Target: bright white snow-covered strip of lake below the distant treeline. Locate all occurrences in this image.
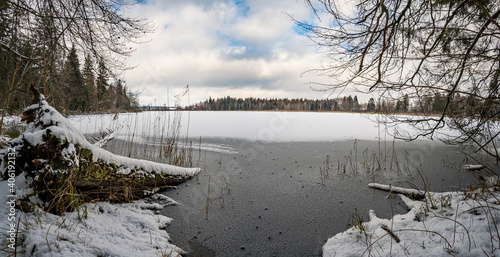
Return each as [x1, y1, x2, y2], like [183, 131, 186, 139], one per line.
[71, 111, 414, 142]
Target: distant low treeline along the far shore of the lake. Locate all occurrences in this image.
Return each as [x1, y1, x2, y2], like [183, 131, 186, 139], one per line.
[188, 93, 500, 116]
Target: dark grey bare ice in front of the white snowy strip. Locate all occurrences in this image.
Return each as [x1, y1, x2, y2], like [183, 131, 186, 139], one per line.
[103, 138, 482, 256]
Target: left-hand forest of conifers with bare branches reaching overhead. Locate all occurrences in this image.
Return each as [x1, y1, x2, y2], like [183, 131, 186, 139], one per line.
[0, 1, 145, 117]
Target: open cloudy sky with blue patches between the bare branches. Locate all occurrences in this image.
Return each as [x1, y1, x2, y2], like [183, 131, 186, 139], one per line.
[121, 0, 336, 105]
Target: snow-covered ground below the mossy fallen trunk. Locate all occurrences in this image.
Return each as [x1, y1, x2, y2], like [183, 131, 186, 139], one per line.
[0, 177, 186, 257]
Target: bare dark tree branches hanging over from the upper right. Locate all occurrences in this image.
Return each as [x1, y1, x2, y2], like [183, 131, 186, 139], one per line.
[296, 0, 500, 159]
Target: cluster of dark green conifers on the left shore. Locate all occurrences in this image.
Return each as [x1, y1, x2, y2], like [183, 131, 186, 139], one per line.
[0, 44, 139, 113]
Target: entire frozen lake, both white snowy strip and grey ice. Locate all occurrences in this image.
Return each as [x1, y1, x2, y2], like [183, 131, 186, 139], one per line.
[71, 112, 488, 256]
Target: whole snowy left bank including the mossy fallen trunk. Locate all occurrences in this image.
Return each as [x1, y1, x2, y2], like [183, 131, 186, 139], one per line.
[0, 92, 200, 254]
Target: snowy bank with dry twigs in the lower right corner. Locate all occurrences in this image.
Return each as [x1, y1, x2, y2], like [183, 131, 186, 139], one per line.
[323, 184, 500, 257]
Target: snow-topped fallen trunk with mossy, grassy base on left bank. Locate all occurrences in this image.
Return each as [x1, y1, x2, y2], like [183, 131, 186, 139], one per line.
[0, 89, 200, 213]
